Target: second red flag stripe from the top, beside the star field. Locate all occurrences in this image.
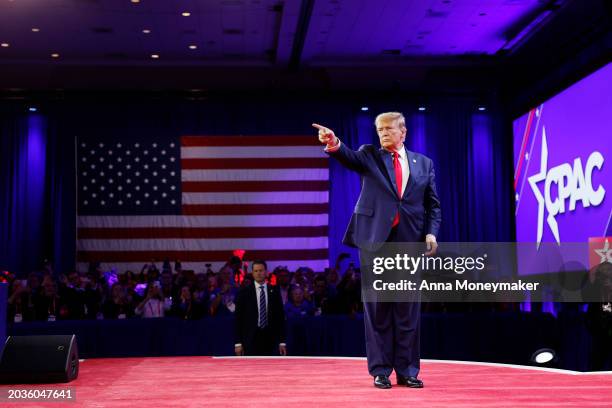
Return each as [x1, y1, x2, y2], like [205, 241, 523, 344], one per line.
[181, 157, 328, 170]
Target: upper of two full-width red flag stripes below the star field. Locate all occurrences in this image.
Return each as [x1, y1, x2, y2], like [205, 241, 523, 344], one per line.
[78, 226, 328, 239]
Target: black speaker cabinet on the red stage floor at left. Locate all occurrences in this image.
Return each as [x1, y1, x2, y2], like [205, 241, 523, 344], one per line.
[0, 334, 79, 384]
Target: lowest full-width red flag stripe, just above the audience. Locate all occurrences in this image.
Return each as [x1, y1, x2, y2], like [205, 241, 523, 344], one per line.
[77, 249, 328, 262]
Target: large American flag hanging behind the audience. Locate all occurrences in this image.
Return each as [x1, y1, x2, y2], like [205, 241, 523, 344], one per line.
[76, 136, 329, 272]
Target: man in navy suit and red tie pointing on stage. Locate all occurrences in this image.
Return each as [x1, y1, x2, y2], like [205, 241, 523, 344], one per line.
[313, 112, 441, 388]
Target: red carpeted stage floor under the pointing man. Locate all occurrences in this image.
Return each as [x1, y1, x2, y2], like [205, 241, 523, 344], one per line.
[4, 357, 612, 408]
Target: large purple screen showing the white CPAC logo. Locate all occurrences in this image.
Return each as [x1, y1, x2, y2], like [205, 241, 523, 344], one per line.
[513, 64, 612, 274]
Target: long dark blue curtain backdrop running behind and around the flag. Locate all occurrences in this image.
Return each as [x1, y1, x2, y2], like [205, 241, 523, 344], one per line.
[0, 98, 514, 275]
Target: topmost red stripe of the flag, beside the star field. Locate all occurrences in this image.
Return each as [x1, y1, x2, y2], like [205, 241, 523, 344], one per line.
[181, 135, 321, 147]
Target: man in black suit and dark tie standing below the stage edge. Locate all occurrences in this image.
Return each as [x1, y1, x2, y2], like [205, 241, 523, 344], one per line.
[234, 260, 287, 356]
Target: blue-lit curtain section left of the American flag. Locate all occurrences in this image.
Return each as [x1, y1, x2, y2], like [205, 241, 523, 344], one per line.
[0, 110, 75, 276]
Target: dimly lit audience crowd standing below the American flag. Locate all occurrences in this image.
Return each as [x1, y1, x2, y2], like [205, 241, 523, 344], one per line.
[6, 257, 363, 323]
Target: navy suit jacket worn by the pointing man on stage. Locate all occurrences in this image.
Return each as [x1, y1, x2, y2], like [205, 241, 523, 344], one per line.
[328, 143, 442, 250]
